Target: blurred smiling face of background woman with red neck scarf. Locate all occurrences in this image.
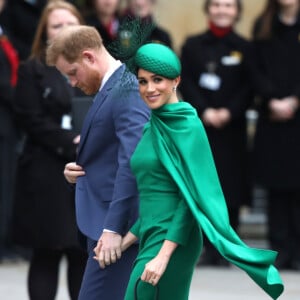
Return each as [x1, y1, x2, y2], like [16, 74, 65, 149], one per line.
[208, 0, 239, 28]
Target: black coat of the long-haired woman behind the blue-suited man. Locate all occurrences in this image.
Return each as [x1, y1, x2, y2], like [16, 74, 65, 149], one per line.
[13, 60, 81, 248]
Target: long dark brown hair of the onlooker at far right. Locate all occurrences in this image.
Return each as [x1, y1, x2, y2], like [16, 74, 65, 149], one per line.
[254, 0, 300, 40]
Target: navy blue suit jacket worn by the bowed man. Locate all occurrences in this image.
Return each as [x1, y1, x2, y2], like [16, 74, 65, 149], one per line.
[76, 65, 150, 241]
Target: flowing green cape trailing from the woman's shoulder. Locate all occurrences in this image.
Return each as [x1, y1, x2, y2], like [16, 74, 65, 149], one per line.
[150, 102, 284, 299]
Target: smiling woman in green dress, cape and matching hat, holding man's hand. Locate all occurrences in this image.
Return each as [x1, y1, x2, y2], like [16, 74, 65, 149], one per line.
[96, 43, 283, 300]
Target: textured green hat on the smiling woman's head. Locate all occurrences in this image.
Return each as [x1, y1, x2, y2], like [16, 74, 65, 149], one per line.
[135, 43, 181, 79]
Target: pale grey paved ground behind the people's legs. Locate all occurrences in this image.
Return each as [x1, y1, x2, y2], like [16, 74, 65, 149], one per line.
[0, 262, 300, 300]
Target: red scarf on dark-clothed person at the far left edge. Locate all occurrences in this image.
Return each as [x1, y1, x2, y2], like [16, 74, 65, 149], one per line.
[0, 36, 19, 87]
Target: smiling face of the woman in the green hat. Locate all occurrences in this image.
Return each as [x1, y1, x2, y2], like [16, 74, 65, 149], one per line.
[138, 69, 180, 109]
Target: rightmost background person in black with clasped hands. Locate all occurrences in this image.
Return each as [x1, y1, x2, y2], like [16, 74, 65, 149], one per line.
[253, 0, 300, 270]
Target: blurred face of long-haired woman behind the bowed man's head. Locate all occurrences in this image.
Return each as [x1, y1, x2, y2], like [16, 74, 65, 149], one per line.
[47, 8, 79, 41]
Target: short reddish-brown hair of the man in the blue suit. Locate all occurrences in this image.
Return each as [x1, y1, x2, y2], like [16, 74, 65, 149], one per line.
[46, 25, 103, 66]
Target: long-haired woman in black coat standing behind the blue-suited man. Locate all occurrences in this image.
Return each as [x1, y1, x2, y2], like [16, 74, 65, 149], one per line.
[13, 0, 87, 300]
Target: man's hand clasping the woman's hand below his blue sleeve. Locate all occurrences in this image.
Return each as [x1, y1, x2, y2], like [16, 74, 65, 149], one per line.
[94, 232, 122, 269]
